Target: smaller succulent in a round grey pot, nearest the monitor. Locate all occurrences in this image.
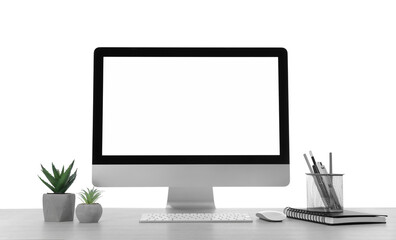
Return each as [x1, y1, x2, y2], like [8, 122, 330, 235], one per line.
[76, 187, 103, 223]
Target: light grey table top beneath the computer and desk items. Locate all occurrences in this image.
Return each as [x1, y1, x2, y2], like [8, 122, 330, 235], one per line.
[0, 208, 396, 240]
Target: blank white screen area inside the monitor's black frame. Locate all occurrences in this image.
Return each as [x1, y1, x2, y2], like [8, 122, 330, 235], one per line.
[102, 57, 279, 155]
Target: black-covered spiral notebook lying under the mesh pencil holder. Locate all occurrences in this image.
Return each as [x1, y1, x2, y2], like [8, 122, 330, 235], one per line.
[283, 207, 387, 225]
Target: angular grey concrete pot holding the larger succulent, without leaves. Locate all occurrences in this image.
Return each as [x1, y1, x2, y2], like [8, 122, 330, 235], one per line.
[43, 193, 76, 222]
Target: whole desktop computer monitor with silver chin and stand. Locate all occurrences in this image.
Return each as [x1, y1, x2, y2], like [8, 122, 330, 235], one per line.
[92, 48, 290, 208]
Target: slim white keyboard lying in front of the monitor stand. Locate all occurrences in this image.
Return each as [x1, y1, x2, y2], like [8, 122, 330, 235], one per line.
[140, 213, 253, 223]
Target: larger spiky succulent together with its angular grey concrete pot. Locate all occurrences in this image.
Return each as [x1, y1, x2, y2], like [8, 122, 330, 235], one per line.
[39, 160, 77, 222]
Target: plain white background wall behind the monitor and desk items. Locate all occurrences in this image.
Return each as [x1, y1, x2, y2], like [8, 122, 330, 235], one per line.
[0, 0, 396, 208]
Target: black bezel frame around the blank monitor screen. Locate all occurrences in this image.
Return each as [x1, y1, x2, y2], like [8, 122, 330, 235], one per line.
[92, 47, 289, 165]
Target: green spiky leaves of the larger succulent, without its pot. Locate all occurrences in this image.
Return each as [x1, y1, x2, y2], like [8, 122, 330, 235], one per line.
[39, 160, 77, 193]
